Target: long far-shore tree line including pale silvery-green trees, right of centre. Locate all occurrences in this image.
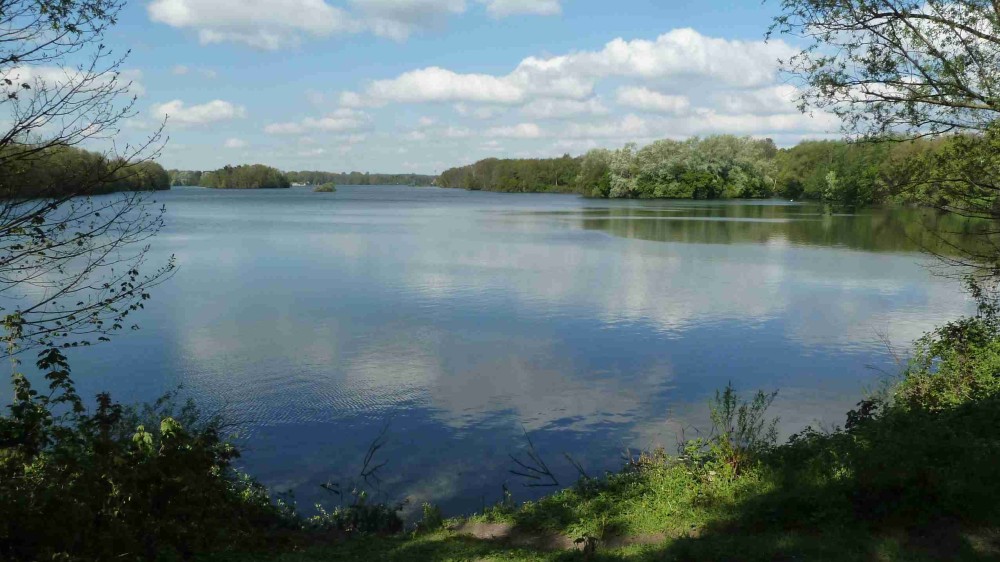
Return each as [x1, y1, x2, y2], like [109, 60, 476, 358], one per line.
[437, 135, 956, 206]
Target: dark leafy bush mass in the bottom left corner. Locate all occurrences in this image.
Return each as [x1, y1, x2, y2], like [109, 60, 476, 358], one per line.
[0, 349, 295, 560]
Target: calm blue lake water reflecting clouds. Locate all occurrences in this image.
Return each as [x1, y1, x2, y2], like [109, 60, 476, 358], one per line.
[62, 187, 971, 514]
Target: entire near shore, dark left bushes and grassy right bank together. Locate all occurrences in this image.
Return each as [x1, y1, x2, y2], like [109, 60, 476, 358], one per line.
[0, 294, 1000, 562]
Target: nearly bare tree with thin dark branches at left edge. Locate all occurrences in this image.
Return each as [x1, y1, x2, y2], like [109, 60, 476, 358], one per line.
[0, 0, 173, 356]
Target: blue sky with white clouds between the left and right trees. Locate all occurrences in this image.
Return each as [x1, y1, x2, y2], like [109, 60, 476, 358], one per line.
[99, 0, 838, 174]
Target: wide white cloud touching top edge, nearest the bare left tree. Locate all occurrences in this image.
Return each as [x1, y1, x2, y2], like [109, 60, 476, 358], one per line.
[147, 0, 362, 49]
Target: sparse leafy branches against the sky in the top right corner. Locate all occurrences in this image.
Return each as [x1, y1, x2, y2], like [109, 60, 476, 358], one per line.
[771, 0, 1000, 138]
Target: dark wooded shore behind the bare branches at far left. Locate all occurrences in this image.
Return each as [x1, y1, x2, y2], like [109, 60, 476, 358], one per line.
[0, 145, 170, 199]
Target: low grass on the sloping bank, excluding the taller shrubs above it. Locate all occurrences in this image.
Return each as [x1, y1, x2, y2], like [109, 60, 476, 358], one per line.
[208, 392, 1000, 562]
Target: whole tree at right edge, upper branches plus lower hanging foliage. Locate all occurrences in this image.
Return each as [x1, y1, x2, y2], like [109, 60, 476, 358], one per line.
[771, 0, 1000, 274]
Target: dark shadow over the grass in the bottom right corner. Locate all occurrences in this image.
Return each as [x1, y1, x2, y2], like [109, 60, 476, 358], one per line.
[632, 399, 1000, 561]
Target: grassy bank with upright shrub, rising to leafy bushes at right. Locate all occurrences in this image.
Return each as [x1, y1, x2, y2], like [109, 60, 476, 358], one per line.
[207, 296, 1000, 562]
